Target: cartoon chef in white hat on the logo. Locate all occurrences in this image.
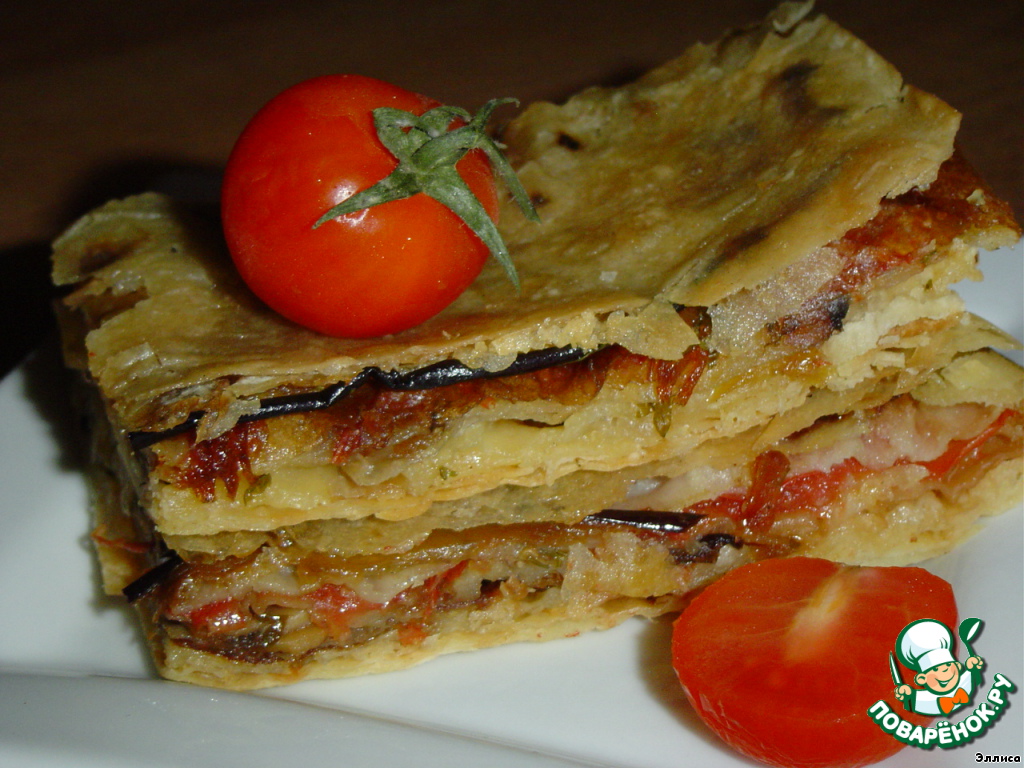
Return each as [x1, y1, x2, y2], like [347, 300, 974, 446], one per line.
[894, 618, 985, 716]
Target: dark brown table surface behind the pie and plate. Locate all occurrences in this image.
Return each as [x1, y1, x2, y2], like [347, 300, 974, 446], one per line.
[0, 0, 1024, 373]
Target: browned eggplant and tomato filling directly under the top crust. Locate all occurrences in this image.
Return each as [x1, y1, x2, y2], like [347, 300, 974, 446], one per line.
[138, 155, 999, 502]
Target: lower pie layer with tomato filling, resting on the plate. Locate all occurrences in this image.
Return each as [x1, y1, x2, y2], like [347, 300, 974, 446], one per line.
[90, 352, 1024, 688]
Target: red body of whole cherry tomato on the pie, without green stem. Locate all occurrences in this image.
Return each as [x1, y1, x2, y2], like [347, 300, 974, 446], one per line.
[221, 75, 498, 338]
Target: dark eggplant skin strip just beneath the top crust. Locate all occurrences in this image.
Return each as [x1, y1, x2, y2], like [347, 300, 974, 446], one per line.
[128, 346, 594, 451]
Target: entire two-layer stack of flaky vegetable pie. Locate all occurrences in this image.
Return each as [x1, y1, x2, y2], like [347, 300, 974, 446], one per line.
[53, 5, 1021, 687]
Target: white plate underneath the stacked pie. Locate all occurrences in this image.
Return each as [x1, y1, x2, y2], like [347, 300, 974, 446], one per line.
[0, 245, 1024, 768]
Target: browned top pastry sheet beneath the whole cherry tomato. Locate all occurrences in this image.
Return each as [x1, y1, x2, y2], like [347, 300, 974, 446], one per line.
[54, 6, 1016, 434]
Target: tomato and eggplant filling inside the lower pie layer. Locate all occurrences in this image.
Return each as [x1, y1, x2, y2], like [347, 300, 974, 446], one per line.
[129, 396, 1024, 665]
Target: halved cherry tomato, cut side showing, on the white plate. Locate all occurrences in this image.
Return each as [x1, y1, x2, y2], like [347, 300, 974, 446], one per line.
[672, 557, 956, 768]
